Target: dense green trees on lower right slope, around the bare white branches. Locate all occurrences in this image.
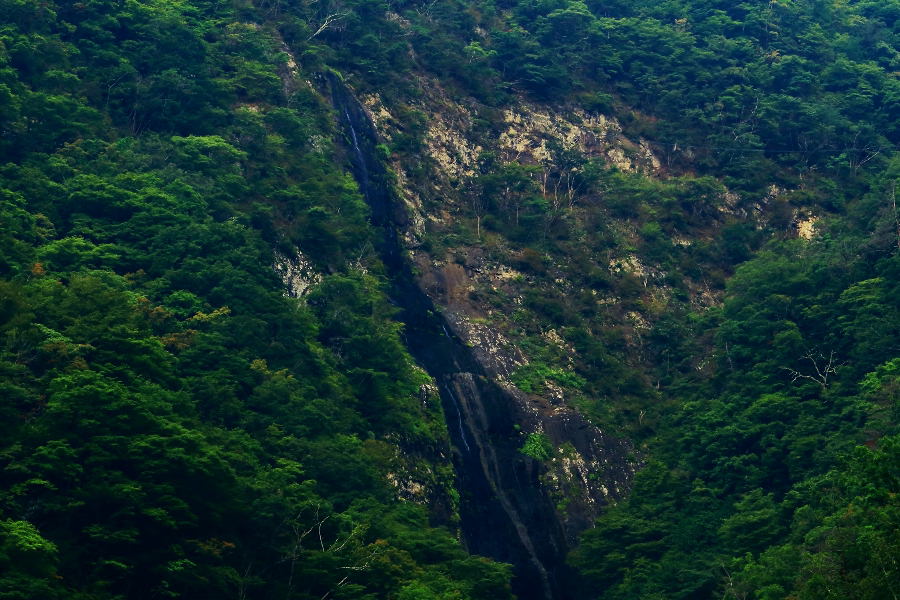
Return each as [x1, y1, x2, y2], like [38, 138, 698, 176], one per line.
[571, 220, 898, 599]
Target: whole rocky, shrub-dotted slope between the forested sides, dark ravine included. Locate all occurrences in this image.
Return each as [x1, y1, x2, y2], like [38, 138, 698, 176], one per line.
[310, 52, 892, 598]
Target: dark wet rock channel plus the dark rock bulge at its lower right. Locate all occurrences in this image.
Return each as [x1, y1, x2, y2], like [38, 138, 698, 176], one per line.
[328, 77, 636, 598]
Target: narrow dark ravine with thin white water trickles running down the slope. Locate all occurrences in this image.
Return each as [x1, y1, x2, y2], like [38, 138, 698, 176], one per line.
[327, 76, 632, 600]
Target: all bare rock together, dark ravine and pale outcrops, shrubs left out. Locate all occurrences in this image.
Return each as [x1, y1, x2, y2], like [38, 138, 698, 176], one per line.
[308, 70, 744, 598]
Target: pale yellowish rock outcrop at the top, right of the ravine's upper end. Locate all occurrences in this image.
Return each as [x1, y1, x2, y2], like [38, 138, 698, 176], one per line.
[362, 79, 661, 248]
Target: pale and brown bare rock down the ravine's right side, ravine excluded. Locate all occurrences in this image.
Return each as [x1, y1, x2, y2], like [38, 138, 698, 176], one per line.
[365, 77, 648, 576]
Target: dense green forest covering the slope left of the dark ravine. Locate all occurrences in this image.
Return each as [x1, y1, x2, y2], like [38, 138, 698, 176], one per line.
[0, 1, 510, 600]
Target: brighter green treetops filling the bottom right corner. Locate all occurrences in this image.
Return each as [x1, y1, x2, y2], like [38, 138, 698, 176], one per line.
[735, 436, 900, 600]
